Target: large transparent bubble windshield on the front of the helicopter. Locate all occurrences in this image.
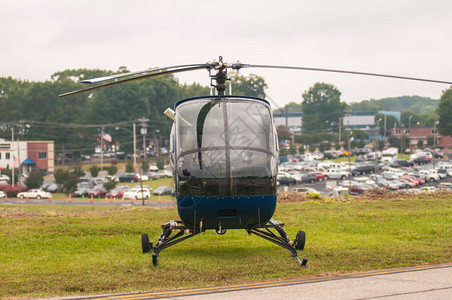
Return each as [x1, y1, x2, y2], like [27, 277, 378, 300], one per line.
[175, 97, 277, 196]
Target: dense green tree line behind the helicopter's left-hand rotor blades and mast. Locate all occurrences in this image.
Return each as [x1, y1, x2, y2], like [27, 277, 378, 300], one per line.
[0, 67, 266, 155]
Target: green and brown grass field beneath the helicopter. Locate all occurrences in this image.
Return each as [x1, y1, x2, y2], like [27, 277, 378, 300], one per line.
[0, 194, 452, 298]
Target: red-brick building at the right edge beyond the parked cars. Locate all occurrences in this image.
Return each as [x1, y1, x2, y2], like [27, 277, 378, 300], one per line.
[391, 127, 452, 150]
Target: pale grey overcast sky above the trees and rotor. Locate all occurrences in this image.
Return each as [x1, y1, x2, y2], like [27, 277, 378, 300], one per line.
[0, 0, 452, 106]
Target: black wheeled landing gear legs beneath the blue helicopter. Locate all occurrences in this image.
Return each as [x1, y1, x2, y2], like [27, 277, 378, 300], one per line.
[141, 219, 308, 266]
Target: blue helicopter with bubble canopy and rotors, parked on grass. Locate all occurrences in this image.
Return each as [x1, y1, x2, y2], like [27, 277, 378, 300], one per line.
[60, 56, 451, 266]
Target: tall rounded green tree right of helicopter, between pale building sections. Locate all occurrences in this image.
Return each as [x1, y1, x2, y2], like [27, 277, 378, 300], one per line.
[302, 83, 347, 133]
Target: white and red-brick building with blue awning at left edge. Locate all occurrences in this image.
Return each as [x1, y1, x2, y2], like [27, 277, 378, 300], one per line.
[0, 139, 55, 174]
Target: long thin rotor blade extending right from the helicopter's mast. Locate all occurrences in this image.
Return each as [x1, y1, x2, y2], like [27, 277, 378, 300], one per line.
[240, 64, 452, 84]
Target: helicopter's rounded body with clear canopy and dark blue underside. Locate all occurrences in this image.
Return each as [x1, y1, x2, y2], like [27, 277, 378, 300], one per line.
[170, 96, 278, 230]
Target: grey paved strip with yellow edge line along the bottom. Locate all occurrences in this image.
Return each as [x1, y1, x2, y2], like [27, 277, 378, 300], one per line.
[85, 263, 452, 300]
